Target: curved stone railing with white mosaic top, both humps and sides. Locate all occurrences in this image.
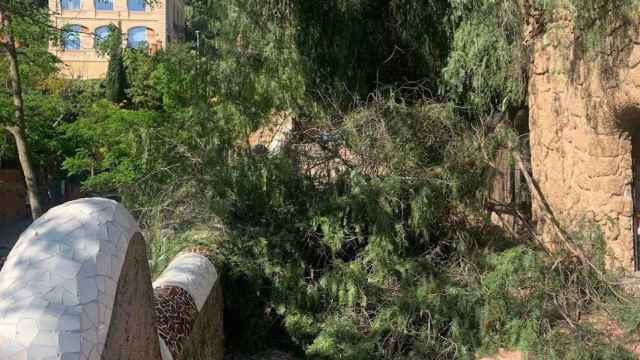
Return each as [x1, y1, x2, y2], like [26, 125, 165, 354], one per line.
[0, 199, 223, 360]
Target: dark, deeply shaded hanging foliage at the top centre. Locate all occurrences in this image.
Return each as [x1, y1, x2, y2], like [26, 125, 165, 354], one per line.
[292, 0, 450, 101]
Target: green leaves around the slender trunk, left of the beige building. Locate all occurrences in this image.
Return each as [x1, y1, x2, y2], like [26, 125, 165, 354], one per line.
[0, 0, 66, 172]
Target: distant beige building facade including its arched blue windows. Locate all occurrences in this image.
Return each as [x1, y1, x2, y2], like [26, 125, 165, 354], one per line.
[49, 0, 185, 79]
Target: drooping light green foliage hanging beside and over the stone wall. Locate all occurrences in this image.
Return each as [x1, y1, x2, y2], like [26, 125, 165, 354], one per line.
[440, 0, 638, 113]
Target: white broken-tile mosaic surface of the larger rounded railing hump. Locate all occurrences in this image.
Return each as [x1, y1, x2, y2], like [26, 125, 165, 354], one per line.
[0, 198, 139, 360]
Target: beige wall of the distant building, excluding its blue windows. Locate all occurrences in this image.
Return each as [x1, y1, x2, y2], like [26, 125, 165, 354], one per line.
[49, 0, 185, 79]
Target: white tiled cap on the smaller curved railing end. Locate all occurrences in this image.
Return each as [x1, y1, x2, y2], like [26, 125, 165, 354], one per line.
[153, 253, 218, 311]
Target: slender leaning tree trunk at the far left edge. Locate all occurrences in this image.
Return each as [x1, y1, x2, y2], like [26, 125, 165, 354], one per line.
[0, 8, 42, 220]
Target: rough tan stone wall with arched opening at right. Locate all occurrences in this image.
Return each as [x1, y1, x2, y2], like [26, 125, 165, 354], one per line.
[528, 11, 640, 271]
